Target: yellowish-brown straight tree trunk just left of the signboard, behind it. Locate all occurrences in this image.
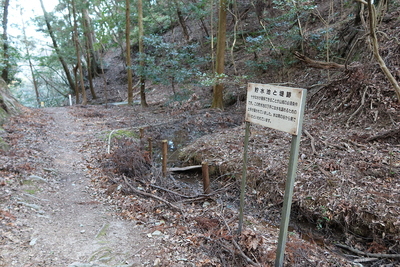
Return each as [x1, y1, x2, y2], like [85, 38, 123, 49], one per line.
[211, 0, 228, 109]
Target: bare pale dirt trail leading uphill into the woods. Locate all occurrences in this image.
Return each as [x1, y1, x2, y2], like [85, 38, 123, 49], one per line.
[0, 108, 160, 267]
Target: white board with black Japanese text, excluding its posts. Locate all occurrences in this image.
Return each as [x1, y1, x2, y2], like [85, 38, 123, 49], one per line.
[246, 83, 305, 135]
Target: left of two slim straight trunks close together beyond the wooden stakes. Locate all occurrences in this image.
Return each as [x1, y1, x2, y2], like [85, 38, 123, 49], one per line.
[125, 0, 133, 105]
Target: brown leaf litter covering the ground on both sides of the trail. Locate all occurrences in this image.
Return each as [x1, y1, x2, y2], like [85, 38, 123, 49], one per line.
[0, 91, 400, 266]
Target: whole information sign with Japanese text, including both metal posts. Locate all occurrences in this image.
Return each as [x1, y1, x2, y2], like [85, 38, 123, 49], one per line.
[238, 83, 307, 267]
